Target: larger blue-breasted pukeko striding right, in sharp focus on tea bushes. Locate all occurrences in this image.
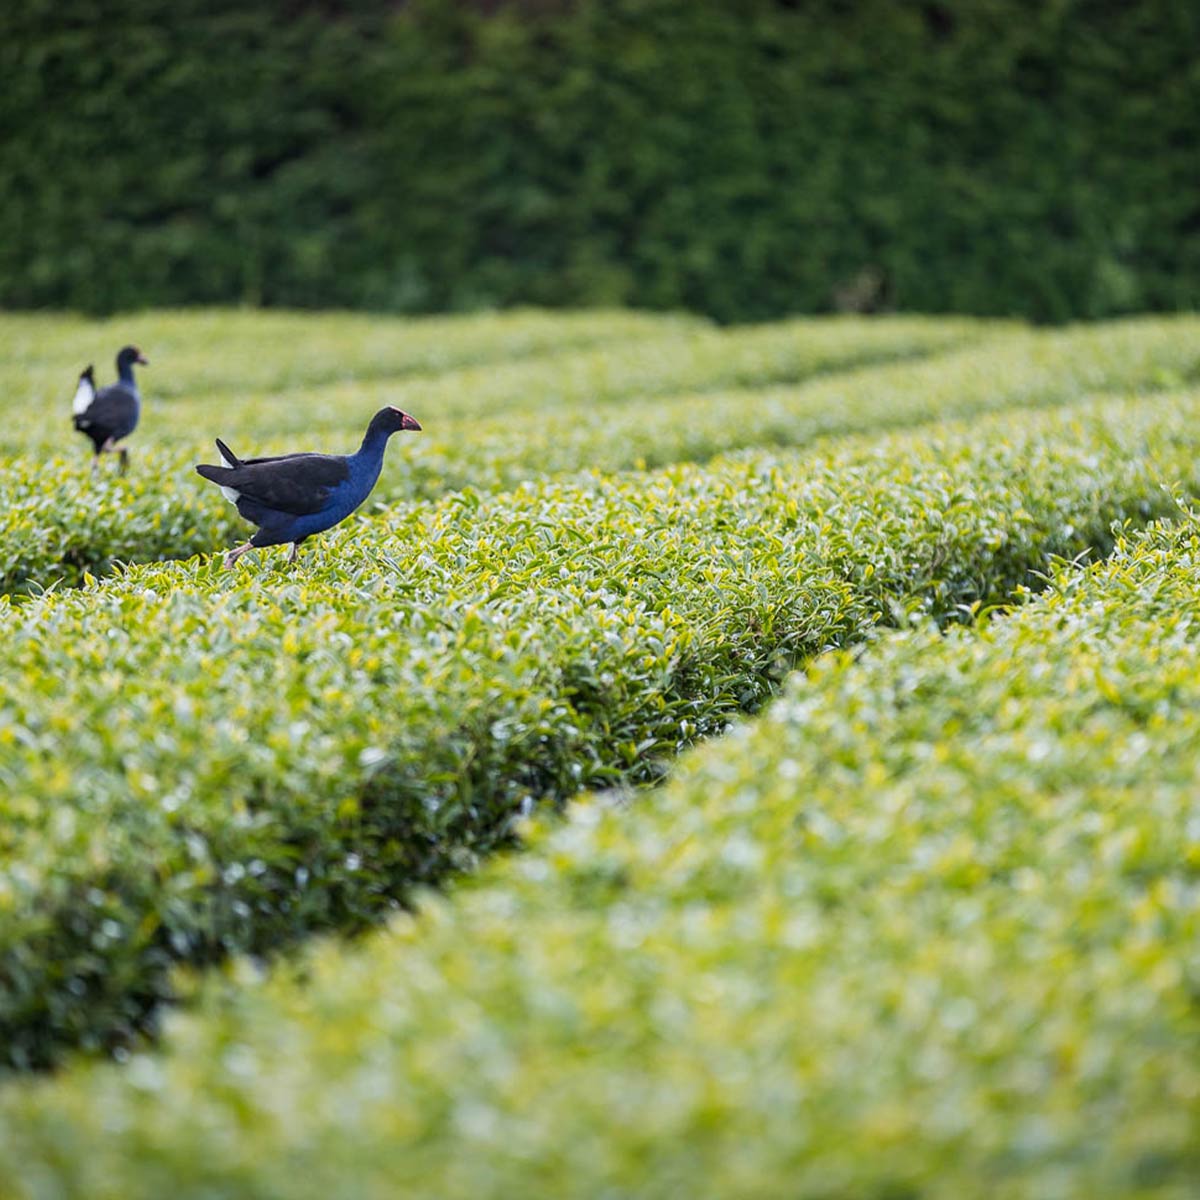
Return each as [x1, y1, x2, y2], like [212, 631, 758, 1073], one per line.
[196, 408, 421, 566]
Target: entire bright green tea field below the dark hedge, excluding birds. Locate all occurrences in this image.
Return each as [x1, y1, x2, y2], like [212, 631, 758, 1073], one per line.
[0, 312, 1200, 1200]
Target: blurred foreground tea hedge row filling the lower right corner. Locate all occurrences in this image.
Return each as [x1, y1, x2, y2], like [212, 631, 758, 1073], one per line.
[7, 520, 1200, 1200]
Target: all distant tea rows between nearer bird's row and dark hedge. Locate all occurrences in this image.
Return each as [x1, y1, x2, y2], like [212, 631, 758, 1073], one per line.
[0, 312, 1200, 594]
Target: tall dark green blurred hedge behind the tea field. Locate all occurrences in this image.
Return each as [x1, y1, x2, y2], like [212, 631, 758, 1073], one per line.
[0, 0, 1200, 320]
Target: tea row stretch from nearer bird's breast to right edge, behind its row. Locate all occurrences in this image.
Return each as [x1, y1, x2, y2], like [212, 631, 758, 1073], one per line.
[403, 317, 1200, 497]
